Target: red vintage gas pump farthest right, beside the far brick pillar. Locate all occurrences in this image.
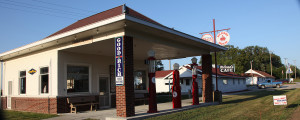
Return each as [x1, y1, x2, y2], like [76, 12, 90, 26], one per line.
[191, 57, 199, 105]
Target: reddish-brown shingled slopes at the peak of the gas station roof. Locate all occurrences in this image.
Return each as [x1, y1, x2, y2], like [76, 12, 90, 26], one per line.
[47, 5, 162, 38]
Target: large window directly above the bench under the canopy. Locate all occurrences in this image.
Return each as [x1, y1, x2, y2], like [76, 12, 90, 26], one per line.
[67, 65, 89, 93]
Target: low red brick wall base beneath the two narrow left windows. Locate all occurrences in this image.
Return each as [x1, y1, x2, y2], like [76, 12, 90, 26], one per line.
[11, 97, 57, 114]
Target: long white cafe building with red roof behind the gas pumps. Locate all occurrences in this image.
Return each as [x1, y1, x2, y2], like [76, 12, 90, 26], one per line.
[156, 66, 247, 94]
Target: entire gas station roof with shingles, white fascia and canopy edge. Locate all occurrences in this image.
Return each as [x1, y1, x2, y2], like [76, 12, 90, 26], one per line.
[0, 5, 227, 60]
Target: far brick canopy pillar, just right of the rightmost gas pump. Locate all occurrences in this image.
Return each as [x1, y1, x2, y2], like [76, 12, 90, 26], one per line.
[201, 54, 213, 103]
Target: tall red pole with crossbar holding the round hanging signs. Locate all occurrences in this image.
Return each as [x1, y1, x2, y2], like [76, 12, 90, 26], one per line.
[199, 19, 230, 91]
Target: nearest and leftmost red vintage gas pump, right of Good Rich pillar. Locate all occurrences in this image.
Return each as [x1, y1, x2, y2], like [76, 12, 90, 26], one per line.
[148, 50, 157, 113]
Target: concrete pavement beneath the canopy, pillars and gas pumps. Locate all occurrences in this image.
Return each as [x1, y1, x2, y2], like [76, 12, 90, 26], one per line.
[46, 98, 218, 120]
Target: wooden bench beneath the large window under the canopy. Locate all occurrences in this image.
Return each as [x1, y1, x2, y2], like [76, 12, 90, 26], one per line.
[67, 96, 99, 113]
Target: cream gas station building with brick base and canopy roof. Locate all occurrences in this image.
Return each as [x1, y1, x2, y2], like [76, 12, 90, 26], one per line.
[0, 5, 227, 114]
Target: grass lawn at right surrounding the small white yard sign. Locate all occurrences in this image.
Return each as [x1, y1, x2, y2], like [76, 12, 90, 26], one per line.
[149, 89, 300, 120]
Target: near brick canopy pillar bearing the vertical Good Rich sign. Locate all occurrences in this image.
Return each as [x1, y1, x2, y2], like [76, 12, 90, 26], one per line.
[116, 36, 135, 117]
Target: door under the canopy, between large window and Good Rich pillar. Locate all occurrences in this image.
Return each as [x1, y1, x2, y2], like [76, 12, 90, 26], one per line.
[99, 77, 110, 108]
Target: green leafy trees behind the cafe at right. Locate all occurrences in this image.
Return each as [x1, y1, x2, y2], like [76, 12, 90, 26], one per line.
[207, 45, 300, 79]
